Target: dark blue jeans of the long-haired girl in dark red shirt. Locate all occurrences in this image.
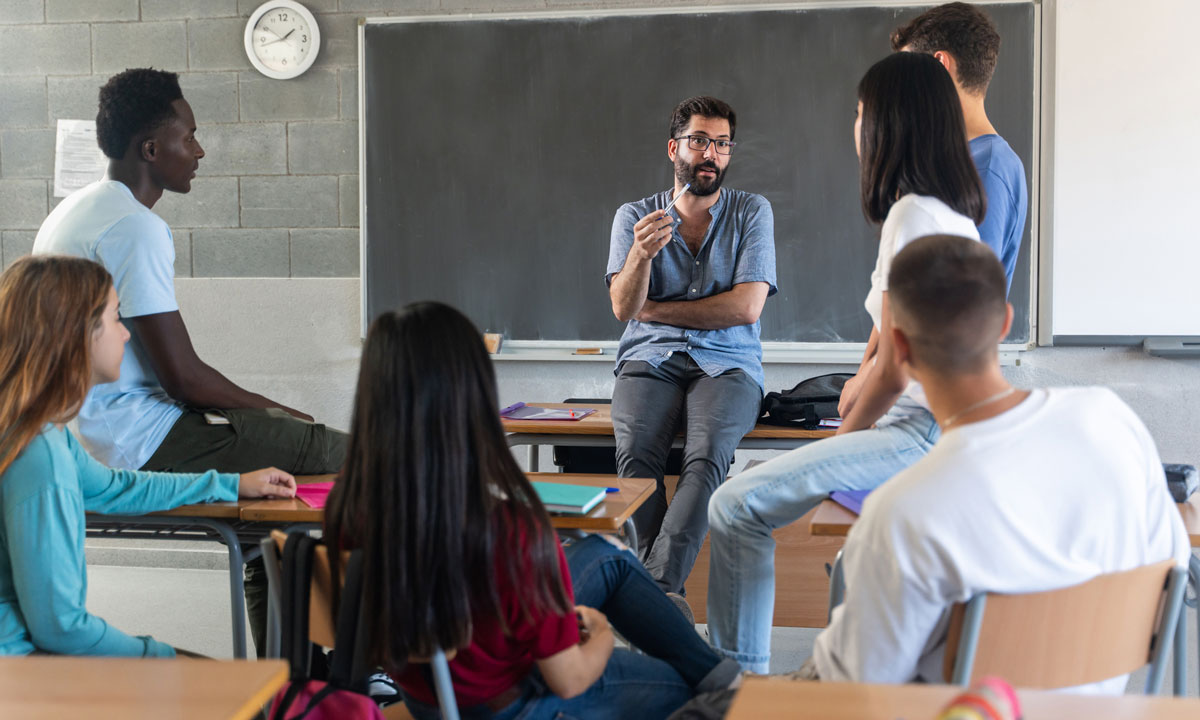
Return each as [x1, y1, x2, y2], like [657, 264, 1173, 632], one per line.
[404, 535, 739, 720]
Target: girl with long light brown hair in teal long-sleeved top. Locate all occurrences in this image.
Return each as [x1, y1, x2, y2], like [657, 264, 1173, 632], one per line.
[0, 256, 295, 658]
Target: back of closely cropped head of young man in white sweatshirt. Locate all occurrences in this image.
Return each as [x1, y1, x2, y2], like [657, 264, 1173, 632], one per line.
[888, 235, 1008, 374]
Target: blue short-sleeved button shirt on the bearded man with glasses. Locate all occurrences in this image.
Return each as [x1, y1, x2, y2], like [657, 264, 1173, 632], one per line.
[605, 188, 776, 389]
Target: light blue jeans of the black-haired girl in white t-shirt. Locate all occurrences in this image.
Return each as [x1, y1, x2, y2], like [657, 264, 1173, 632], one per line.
[708, 396, 941, 673]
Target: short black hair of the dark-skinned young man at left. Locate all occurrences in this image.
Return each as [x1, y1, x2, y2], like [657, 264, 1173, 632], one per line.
[96, 67, 184, 160]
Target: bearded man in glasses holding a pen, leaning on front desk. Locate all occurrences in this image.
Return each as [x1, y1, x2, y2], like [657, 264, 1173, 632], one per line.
[605, 97, 775, 616]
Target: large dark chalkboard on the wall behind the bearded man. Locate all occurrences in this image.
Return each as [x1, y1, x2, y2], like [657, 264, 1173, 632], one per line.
[360, 4, 1037, 343]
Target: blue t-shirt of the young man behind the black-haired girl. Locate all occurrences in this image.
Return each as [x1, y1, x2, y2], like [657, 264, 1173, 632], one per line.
[971, 134, 1030, 288]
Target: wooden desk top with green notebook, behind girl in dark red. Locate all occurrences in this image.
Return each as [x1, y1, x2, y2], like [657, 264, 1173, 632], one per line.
[241, 473, 654, 532]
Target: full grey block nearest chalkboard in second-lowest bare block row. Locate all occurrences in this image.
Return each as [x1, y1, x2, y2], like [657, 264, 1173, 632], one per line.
[241, 175, 337, 228]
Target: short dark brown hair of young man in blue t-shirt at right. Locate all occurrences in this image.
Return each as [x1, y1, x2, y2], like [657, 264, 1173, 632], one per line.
[892, 2, 1000, 92]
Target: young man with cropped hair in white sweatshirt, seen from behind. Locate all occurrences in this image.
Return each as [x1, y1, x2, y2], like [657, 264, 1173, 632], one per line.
[814, 236, 1190, 694]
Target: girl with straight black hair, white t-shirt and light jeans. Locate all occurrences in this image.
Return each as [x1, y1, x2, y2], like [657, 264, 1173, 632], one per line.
[708, 53, 986, 672]
